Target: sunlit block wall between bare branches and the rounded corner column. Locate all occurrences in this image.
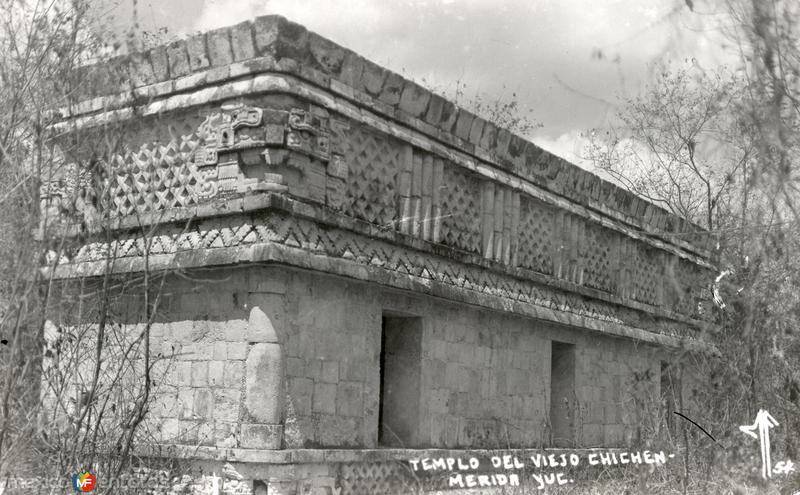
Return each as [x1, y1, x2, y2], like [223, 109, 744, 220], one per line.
[143, 283, 250, 447]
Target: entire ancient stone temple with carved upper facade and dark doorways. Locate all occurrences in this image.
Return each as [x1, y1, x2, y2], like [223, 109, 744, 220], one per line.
[43, 16, 714, 494]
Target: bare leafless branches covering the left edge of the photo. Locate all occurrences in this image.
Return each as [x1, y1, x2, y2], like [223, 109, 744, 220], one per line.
[0, 0, 175, 490]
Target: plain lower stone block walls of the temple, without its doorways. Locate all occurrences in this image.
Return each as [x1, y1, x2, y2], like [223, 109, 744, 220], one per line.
[75, 267, 661, 454]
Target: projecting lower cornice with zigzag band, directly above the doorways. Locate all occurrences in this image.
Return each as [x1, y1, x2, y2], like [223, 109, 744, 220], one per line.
[43, 193, 706, 348]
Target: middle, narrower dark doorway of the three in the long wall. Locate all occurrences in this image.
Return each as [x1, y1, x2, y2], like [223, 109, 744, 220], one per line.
[550, 341, 576, 447]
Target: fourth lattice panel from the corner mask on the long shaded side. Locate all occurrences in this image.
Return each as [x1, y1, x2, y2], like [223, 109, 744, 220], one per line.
[582, 222, 618, 293]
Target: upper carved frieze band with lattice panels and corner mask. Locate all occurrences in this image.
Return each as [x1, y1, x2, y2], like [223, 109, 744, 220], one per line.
[43, 101, 708, 326]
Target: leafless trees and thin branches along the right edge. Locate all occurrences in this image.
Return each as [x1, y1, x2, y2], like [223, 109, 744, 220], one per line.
[588, 0, 800, 490]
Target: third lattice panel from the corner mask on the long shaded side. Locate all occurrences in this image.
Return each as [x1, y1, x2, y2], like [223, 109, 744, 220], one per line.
[518, 196, 555, 275]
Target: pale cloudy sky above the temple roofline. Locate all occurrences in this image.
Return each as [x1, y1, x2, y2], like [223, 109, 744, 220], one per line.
[102, 0, 736, 168]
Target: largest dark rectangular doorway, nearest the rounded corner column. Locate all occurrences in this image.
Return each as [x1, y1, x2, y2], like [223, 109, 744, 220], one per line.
[378, 314, 422, 447]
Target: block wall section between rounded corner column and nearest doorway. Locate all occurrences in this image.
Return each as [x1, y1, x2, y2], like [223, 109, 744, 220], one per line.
[285, 272, 381, 448]
